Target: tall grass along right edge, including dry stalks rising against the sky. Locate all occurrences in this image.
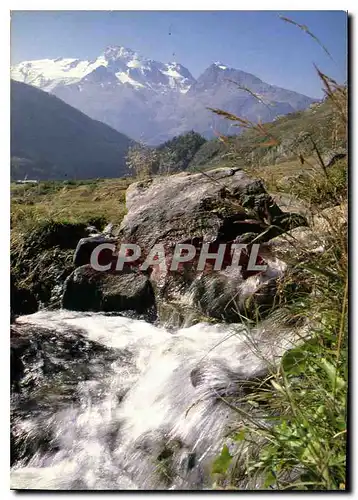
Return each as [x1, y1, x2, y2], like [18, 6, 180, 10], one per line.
[208, 17, 349, 491]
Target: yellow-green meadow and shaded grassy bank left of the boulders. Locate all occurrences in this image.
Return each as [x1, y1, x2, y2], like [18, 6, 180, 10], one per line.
[10, 179, 130, 313]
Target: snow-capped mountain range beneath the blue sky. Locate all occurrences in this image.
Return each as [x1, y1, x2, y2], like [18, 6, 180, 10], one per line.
[11, 46, 314, 144]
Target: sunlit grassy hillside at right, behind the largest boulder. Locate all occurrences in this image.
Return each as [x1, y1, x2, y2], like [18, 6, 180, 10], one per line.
[191, 98, 346, 171]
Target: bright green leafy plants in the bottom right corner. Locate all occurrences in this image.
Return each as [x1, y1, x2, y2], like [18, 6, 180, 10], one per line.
[249, 324, 347, 490]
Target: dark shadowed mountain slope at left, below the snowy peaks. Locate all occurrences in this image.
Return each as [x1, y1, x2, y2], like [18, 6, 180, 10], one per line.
[11, 80, 133, 180]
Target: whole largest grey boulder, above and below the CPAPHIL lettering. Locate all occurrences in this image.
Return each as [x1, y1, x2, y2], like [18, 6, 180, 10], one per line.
[118, 168, 307, 321]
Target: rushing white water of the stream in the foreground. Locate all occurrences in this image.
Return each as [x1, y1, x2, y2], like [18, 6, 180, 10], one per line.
[11, 310, 304, 489]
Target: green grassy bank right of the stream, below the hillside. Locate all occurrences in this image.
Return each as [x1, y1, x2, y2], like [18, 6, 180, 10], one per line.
[213, 215, 348, 490]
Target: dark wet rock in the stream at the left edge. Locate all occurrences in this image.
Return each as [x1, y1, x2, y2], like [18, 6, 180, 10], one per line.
[10, 322, 126, 464]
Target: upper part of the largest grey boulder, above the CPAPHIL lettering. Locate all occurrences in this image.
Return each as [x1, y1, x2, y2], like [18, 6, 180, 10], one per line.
[120, 168, 302, 250]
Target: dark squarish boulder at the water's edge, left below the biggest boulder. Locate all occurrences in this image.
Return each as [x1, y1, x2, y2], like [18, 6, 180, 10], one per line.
[62, 264, 155, 314]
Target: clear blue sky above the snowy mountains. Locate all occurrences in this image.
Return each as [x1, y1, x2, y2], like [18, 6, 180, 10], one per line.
[11, 11, 347, 97]
